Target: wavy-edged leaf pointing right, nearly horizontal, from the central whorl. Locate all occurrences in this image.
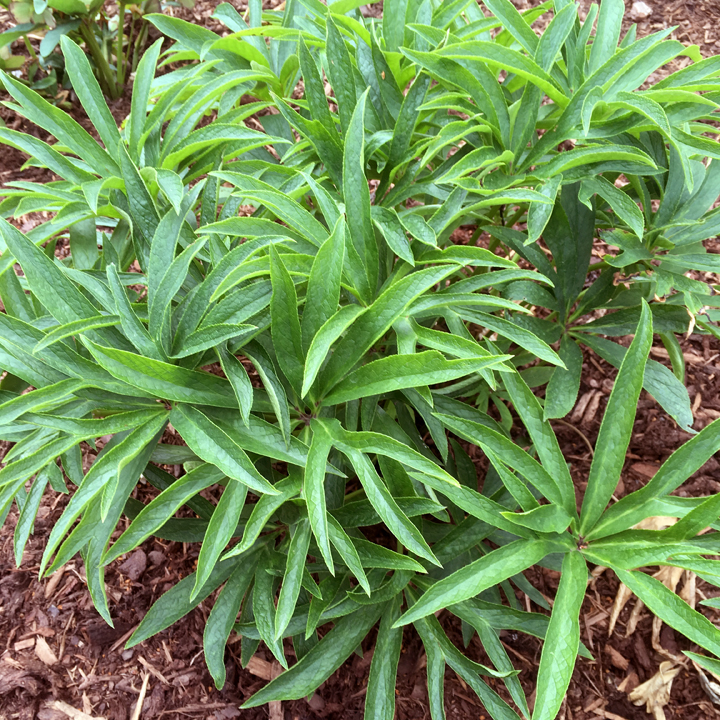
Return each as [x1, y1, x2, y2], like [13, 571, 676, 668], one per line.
[323, 350, 512, 405]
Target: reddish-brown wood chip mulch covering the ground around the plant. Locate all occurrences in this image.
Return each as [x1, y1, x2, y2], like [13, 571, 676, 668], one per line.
[0, 0, 720, 720]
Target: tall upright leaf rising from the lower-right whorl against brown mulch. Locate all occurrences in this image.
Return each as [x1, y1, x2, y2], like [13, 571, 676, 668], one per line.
[579, 301, 652, 536]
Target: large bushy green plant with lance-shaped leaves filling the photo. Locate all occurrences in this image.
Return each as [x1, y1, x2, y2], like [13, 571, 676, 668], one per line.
[0, 2, 720, 718]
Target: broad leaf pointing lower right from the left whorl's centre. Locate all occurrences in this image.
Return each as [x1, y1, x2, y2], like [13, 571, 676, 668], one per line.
[170, 404, 277, 495]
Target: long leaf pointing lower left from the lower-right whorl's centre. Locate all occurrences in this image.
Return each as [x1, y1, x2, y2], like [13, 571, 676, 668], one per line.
[395, 540, 552, 626]
